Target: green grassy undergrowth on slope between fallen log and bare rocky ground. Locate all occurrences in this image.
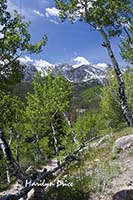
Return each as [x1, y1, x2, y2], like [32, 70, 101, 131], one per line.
[45, 128, 133, 200]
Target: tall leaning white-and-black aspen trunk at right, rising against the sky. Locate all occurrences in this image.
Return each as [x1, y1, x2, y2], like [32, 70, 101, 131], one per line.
[97, 24, 133, 127]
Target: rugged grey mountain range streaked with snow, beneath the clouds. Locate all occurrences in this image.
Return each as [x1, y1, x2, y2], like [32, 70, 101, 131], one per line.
[24, 64, 107, 83]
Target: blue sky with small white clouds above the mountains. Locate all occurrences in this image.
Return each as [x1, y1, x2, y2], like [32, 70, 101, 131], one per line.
[8, 0, 129, 67]
